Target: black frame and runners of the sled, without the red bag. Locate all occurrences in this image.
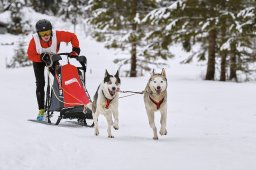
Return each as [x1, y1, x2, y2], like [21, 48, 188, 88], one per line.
[45, 53, 94, 127]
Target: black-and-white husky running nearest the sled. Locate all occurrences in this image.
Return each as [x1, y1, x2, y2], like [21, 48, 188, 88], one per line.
[92, 70, 121, 138]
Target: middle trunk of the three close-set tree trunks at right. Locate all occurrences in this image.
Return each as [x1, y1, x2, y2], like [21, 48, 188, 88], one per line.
[220, 18, 227, 81]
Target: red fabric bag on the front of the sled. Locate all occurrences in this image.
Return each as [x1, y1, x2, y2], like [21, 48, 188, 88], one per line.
[61, 64, 90, 107]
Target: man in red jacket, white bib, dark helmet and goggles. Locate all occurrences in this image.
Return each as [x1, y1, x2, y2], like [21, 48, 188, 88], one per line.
[27, 19, 80, 121]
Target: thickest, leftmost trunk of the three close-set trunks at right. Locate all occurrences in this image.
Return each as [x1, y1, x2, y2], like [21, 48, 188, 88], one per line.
[205, 29, 216, 80]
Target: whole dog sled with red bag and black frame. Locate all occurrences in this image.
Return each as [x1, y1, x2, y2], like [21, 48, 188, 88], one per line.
[42, 53, 94, 127]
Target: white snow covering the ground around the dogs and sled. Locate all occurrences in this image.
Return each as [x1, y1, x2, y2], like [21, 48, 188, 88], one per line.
[0, 10, 256, 170]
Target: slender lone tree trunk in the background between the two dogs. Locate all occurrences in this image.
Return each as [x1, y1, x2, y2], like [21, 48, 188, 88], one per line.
[130, 0, 137, 77]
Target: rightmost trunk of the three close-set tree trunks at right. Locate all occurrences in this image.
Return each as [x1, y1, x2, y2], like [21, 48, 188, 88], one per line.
[229, 42, 237, 81]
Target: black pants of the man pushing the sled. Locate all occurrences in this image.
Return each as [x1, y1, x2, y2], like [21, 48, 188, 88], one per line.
[33, 62, 54, 109]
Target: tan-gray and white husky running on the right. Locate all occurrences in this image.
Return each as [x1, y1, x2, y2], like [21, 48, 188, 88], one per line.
[144, 69, 167, 140]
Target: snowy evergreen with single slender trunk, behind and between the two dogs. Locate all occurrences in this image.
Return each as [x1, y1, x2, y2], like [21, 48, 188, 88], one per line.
[87, 0, 156, 77]
